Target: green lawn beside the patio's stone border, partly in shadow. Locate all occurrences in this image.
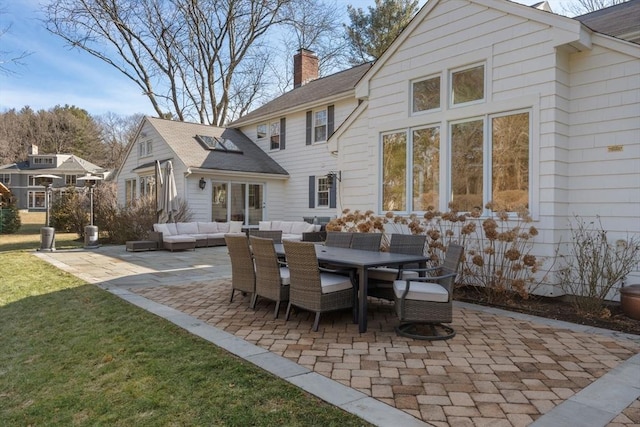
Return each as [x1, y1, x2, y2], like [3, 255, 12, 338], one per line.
[0, 219, 367, 426]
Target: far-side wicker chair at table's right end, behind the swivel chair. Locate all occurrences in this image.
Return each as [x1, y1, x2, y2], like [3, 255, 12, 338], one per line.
[367, 234, 427, 301]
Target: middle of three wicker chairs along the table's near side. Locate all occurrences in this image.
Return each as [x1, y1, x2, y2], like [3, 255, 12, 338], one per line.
[249, 236, 290, 319]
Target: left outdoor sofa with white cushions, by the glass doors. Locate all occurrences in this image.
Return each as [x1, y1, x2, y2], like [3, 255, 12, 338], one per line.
[150, 221, 244, 251]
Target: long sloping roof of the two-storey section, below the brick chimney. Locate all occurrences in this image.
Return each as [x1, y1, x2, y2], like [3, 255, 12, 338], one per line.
[229, 63, 372, 127]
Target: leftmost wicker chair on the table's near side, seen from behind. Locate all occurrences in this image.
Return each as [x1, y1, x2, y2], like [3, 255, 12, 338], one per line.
[224, 234, 256, 306]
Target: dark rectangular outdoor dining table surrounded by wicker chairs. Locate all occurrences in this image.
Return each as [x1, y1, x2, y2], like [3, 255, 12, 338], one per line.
[275, 243, 428, 333]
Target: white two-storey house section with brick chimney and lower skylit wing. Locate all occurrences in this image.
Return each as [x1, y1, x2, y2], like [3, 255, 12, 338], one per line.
[116, 50, 371, 226]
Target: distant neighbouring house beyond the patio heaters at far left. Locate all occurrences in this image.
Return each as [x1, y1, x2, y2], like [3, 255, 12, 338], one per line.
[0, 145, 109, 212]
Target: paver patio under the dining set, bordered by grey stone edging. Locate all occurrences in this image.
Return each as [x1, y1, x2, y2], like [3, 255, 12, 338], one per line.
[40, 247, 640, 426]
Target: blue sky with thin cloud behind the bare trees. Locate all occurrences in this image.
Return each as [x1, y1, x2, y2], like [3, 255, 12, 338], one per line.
[0, 0, 570, 115]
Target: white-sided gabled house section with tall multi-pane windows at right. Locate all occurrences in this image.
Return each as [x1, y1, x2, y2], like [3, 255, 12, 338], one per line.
[329, 0, 640, 288]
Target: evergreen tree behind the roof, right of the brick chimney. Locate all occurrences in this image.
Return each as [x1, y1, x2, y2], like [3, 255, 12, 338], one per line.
[345, 0, 418, 65]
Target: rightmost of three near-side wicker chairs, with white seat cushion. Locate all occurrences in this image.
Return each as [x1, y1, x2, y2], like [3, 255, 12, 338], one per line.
[283, 240, 355, 331]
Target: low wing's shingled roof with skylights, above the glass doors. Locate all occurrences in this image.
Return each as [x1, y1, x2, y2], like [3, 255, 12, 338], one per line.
[145, 117, 288, 175]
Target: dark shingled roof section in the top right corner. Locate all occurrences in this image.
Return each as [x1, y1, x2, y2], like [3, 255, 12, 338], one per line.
[574, 0, 640, 43]
